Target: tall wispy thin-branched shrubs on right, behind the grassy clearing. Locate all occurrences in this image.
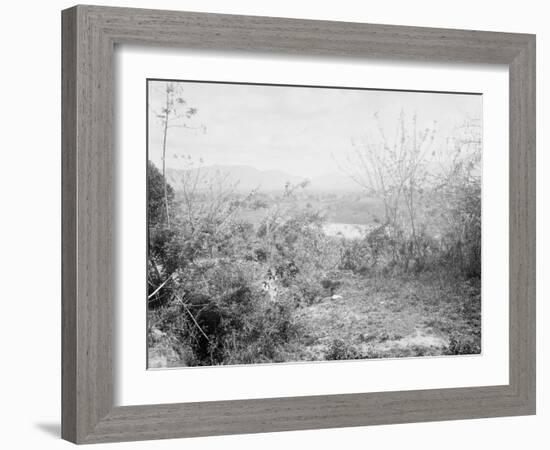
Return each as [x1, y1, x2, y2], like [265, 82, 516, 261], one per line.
[341, 113, 481, 277]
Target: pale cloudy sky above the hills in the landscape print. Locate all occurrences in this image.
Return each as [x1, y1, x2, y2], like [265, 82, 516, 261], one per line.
[148, 80, 482, 178]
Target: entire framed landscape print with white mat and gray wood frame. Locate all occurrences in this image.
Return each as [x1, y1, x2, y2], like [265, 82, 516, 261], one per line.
[62, 6, 536, 443]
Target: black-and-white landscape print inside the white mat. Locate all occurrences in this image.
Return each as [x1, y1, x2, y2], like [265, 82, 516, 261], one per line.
[146, 79, 483, 369]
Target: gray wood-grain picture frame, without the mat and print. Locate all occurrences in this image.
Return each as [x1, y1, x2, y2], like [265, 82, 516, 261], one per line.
[62, 6, 535, 443]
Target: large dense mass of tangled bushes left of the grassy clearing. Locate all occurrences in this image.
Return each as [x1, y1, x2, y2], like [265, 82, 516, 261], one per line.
[149, 166, 322, 365]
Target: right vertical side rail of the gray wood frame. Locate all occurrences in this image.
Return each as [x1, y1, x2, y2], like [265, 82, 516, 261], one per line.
[509, 39, 536, 411]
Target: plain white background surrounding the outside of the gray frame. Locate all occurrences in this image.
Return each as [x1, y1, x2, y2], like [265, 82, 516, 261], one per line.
[0, 0, 550, 450]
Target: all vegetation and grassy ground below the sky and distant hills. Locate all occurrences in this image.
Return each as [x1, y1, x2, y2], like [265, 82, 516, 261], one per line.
[147, 82, 481, 367]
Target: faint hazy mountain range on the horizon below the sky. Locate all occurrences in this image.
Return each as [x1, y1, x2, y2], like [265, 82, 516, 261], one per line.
[166, 165, 360, 192]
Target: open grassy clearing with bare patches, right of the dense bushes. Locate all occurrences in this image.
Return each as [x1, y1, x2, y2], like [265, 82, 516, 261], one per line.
[291, 276, 481, 360]
